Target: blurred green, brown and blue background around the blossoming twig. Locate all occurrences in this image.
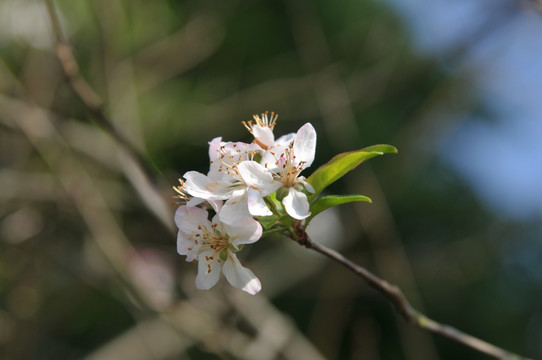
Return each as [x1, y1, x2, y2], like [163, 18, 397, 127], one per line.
[0, 0, 542, 360]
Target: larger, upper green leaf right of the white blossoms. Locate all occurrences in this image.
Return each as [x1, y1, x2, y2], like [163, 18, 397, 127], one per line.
[307, 145, 397, 202]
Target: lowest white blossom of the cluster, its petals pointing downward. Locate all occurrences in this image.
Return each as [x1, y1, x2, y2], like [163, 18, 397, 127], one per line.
[175, 205, 262, 295]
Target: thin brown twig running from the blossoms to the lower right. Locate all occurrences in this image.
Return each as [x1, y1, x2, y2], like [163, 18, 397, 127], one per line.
[294, 234, 528, 360]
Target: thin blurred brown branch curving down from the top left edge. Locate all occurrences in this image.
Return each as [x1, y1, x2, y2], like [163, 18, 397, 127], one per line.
[43, 0, 153, 179]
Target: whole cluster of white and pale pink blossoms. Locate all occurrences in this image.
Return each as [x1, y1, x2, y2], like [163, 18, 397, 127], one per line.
[175, 112, 316, 294]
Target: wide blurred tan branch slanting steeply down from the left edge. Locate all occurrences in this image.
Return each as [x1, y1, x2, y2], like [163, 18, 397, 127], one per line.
[0, 96, 151, 307]
